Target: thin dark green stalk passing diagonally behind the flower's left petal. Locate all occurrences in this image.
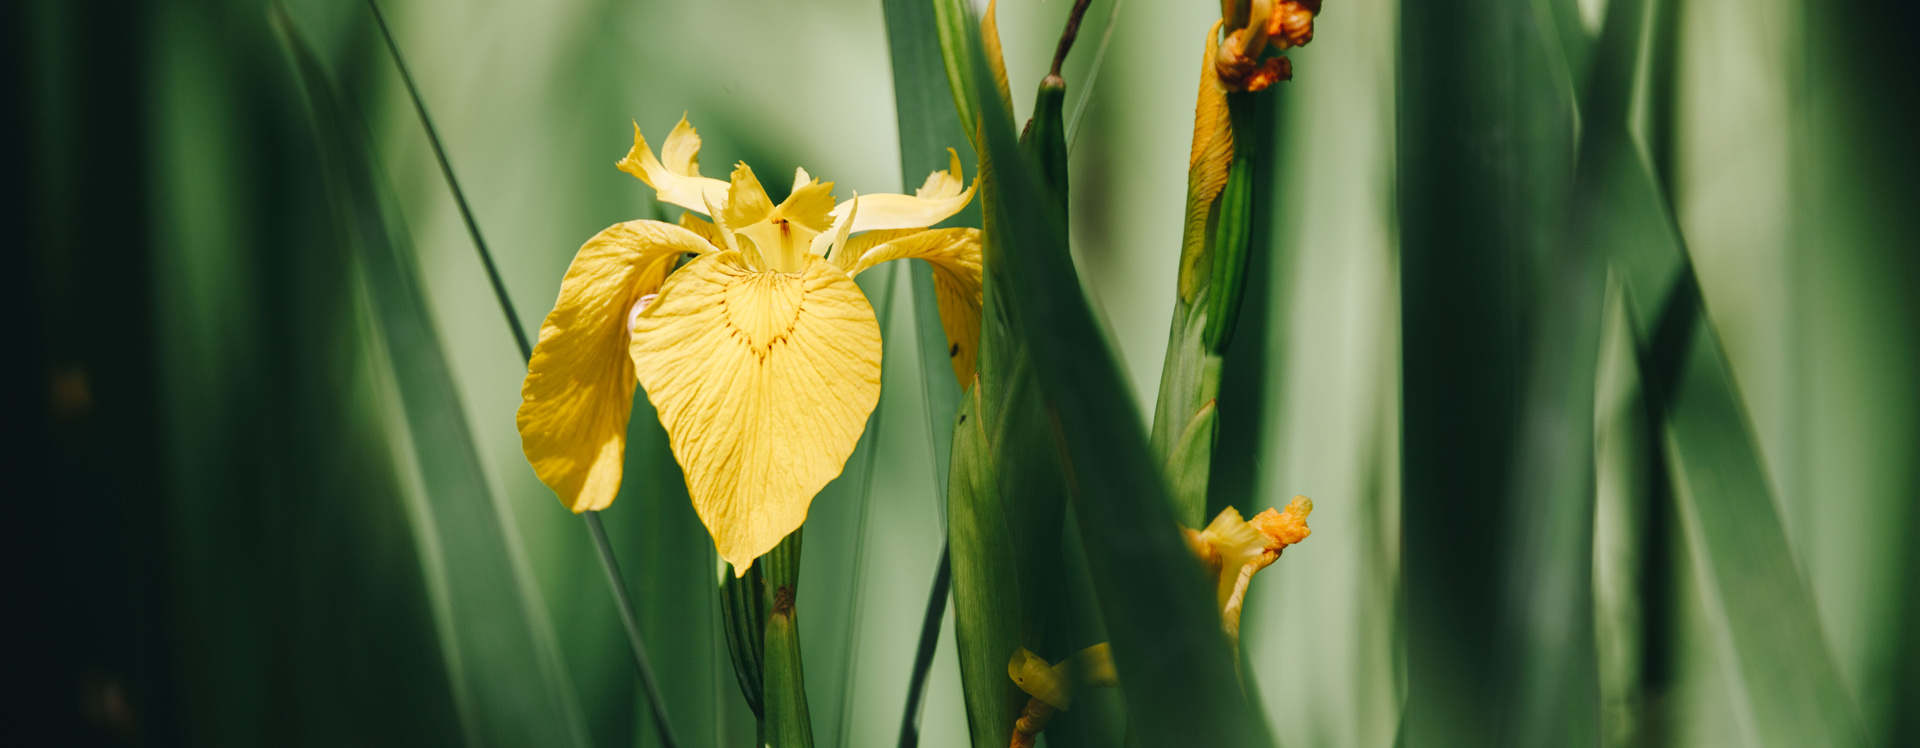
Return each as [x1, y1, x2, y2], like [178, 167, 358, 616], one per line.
[367, 0, 680, 748]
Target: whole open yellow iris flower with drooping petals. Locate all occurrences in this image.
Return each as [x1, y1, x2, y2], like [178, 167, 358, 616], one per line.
[518, 117, 981, 575]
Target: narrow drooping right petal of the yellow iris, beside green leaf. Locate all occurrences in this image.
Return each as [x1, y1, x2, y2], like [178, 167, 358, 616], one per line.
[849, 226, 981, 386]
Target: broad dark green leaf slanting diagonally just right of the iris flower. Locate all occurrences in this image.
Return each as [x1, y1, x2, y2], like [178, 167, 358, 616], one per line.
[941, 2, 1271, 746]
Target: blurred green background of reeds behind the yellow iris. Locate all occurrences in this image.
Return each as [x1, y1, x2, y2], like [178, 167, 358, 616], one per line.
[0, 0, 1920, 746]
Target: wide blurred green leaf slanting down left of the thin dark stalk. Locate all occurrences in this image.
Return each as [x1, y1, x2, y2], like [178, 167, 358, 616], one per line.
[271, 6, 588, 746]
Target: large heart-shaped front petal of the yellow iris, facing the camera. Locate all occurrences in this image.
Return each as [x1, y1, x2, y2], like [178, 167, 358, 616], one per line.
[630, 251, 879, 575]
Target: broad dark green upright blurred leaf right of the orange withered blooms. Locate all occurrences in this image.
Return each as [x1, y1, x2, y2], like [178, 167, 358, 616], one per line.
[1396, 0, 1574, 746]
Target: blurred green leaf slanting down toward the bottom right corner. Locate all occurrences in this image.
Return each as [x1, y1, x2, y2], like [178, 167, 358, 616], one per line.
[1607, 121, 1866, 746]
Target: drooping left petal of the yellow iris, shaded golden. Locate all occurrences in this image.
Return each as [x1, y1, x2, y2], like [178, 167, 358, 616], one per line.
[516, 221, 714, 512]
